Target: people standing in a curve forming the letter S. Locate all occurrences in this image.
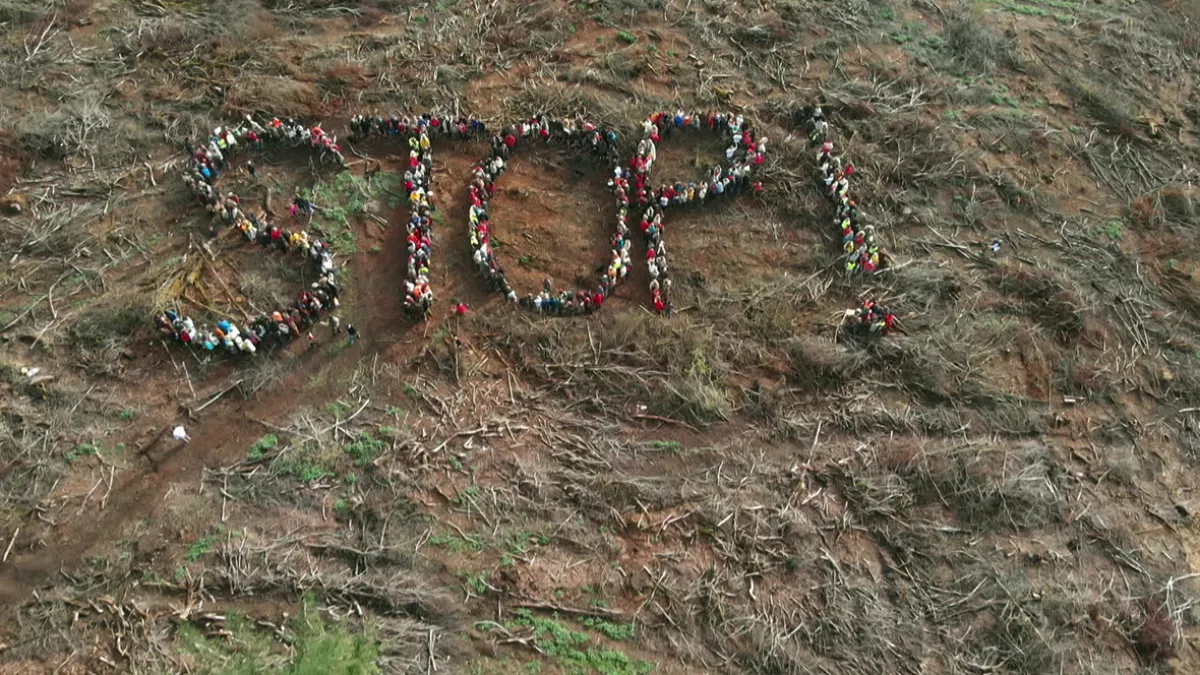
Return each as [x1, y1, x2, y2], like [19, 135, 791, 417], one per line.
[164, 115, 344, 354]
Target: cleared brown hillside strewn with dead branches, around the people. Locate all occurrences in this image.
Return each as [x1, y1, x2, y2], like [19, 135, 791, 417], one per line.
[0, 0, 1200, 675]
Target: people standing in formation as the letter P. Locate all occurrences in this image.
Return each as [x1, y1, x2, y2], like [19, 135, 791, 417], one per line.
[613, 110, 767, 315]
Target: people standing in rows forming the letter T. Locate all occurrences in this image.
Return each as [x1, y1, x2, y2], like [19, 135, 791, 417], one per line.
[350, 114, 487, 317]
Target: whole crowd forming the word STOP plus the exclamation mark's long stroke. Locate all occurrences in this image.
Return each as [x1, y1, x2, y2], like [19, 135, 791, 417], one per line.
[155, 108, 777, 353]
